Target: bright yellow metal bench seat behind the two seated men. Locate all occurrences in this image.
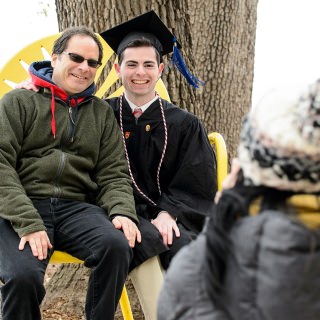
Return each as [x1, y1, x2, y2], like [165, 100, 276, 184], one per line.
[0, 34, 227, 320]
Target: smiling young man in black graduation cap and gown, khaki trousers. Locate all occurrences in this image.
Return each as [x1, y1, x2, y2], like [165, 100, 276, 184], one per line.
[101, 11, 216, 319]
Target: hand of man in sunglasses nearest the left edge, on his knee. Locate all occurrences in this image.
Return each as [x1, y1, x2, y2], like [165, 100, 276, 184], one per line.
[19, 231, 52, 260]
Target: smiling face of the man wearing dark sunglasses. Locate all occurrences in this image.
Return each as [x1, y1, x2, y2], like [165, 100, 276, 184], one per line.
[51, 35, 99, 95]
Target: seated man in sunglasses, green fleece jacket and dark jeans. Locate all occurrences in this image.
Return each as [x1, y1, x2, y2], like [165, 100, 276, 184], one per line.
[0, 27, 141, 320]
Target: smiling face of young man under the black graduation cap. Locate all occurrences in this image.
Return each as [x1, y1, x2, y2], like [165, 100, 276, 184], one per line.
[115, 47, 164, 105]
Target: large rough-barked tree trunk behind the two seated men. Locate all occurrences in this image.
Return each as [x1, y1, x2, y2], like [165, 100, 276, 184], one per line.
[43, 0, 258, 319]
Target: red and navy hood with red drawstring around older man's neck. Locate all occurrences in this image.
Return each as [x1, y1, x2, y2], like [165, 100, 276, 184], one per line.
[29, 61, 96, 138]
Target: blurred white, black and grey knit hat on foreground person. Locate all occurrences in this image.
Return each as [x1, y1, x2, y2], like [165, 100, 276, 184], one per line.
[239, 79, 320, 193]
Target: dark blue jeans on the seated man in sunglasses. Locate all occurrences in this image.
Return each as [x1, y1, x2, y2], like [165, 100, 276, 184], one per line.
[0, 198, 132, 320]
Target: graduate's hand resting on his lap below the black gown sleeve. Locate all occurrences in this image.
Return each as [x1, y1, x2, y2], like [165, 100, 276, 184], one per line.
[151, 211, 180, 246]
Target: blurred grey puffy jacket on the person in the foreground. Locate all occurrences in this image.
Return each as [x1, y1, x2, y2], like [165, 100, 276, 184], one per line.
[158, 197, 320, 320]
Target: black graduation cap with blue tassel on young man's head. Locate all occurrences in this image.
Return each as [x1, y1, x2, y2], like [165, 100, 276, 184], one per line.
[100, 10, 204, 88]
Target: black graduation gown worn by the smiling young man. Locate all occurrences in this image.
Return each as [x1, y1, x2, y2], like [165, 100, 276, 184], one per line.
[108, 97, 217, 268]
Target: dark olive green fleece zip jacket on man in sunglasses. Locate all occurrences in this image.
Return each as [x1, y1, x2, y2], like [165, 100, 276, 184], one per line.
[0, 89, 138, 237]
